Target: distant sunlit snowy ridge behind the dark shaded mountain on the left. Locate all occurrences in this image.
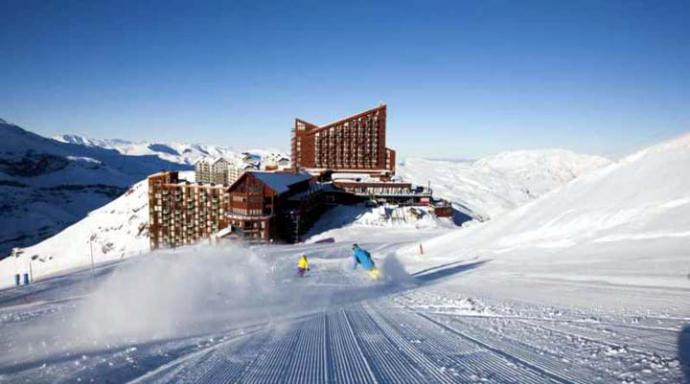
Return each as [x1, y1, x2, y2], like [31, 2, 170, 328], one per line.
[54, 134, 287, 165]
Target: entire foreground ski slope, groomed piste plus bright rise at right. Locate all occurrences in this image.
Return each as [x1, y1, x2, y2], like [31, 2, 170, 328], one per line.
[0, 135, 690, 384]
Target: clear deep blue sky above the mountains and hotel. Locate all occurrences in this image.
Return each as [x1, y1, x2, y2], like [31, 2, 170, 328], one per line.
[0, 0, 690, 158]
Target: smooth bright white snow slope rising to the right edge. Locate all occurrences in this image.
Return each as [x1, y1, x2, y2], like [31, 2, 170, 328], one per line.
[403, 134, 690, 290]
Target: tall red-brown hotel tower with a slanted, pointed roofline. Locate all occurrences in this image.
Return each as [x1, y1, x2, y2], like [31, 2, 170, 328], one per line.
[292, 105, 395, 177]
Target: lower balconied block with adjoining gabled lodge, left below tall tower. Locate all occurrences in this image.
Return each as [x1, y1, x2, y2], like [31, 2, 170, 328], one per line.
[148, 171, 326, 249]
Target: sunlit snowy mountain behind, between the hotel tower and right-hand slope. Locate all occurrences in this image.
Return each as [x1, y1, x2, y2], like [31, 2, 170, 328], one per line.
[397, 150, 610, 220]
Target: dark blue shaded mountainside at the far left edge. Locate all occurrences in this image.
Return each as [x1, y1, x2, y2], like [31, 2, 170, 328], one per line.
[0, 121, 190, 257]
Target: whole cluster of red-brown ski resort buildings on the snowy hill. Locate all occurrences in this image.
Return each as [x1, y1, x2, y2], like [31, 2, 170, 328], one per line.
[149, 105, 453, 249]
